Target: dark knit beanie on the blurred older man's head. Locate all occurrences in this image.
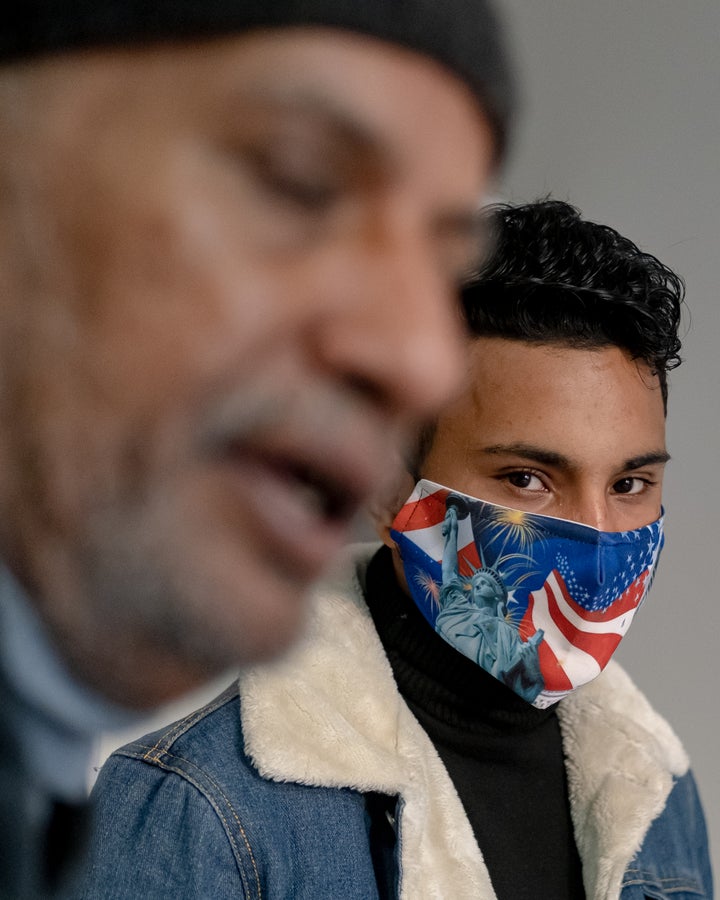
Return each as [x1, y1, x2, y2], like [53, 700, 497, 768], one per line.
[0, 0, 515, 154]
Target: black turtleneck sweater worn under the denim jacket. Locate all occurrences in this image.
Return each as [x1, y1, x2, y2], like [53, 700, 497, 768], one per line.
[366, 547, 585, 900]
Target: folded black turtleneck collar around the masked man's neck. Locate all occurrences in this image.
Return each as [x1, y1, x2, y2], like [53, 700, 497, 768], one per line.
[366, 547, 555, 735]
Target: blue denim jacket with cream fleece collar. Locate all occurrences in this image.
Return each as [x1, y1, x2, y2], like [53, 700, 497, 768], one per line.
[76, 554, 712, 900]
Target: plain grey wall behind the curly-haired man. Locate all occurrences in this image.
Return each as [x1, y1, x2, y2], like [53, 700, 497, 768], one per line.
[499, 0, 720, 879]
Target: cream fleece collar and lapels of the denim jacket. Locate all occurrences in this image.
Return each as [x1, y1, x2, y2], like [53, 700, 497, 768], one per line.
[240, 545, 688, 900]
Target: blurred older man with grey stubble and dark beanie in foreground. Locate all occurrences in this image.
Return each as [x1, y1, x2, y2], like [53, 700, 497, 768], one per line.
[0, 0, 512, 897]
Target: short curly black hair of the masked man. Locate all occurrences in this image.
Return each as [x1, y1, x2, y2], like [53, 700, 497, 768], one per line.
[462, 200, 684, 408]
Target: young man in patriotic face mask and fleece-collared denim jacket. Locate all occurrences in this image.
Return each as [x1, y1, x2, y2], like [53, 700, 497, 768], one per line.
[79, 202, 712, 900]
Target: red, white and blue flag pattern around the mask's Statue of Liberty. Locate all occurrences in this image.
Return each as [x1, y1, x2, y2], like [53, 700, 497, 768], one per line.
[392, 481, 663, 706]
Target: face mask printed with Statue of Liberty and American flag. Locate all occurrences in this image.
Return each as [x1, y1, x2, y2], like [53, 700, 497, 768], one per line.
[391, 480, 663, 709]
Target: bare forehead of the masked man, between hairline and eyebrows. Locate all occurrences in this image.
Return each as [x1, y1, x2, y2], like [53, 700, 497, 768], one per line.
[421, 337, 668, 470]
